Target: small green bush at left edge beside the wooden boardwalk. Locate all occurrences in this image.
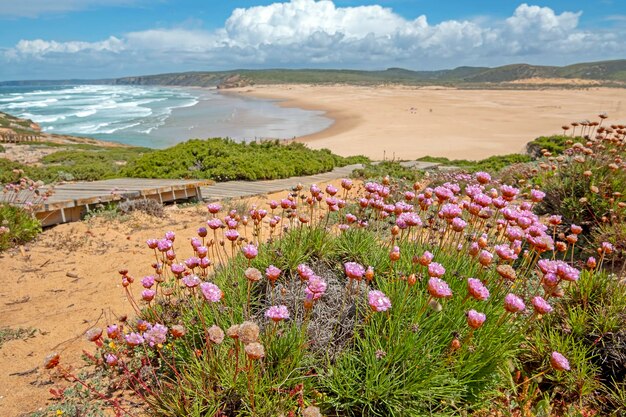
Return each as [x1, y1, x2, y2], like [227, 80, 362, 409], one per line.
[0, 204, 41, 251]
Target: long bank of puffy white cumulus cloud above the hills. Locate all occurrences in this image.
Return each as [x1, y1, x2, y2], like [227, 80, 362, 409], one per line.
[0, 0, 626, 78]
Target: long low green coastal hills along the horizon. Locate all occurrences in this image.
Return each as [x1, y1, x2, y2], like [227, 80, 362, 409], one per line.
[0, 59, 626, 88]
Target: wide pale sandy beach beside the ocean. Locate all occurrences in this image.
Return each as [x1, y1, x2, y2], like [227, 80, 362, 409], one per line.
[236, 85, 626, 159]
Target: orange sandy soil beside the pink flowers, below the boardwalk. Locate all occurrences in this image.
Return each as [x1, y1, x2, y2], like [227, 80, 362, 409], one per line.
[0, 180, 346, 417]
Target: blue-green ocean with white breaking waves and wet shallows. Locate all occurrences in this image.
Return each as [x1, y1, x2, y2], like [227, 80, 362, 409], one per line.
[0, 85, 332, 148]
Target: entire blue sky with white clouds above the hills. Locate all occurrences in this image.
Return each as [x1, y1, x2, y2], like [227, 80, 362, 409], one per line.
[0, 0, 626, 81]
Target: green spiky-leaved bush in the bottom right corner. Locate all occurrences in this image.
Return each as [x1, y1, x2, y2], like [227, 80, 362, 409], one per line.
[522, 271, 626, 415]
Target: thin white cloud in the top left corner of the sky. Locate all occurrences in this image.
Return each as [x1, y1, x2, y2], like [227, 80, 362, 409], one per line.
[0, 0, 139, 17]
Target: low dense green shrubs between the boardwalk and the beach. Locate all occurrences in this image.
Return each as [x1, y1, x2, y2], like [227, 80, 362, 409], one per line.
[123, 138, 364, 181]
